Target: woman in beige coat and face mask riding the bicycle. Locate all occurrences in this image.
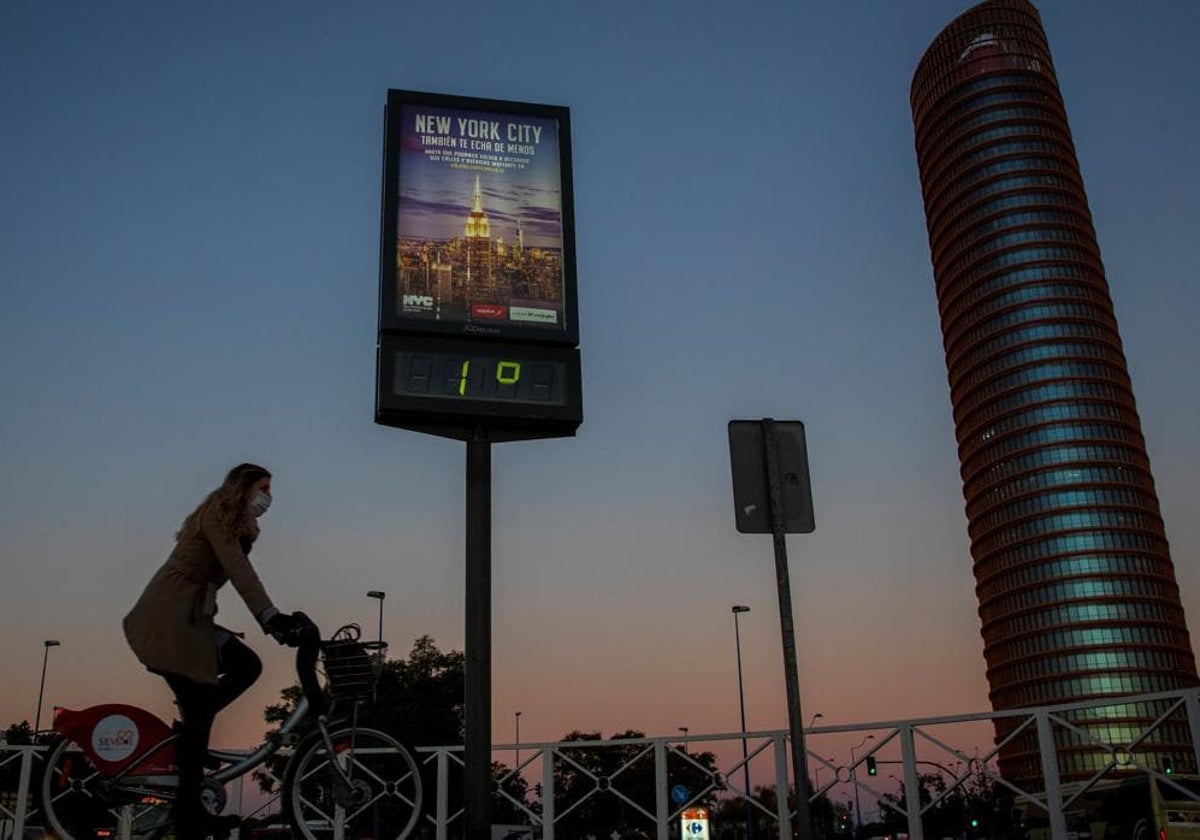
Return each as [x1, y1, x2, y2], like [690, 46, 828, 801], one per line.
[124, 463, 308, 840]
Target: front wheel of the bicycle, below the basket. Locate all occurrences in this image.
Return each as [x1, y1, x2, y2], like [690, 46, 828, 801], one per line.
[283, 728, 421, 840]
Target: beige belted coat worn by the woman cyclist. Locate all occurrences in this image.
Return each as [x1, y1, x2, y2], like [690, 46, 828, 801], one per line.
[125, 514, 274, 683]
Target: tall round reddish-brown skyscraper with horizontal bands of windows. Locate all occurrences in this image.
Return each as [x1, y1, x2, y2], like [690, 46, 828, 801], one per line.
[911, 0, 1196, 779]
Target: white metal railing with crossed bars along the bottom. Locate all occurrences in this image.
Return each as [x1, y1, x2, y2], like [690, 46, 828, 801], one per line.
[7, 689, 1200, 840]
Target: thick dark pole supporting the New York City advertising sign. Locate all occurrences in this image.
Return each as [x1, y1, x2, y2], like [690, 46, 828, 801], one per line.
[462, 430, 492, 840]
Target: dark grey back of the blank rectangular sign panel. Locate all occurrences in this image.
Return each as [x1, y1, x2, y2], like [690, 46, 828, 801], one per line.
[730, 420, 816, 534]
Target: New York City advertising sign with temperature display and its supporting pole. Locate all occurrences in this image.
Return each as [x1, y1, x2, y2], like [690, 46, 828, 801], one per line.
[376, 90, 583, 840]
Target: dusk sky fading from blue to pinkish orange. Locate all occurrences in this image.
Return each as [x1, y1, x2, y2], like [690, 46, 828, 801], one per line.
[0, 0, 1200, 801]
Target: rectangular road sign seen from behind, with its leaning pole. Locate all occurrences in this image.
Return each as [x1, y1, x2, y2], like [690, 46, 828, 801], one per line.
[728, 418, 816, 840]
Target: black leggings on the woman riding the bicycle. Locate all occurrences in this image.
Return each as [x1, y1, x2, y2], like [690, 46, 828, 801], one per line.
[162, 636, 263, 838]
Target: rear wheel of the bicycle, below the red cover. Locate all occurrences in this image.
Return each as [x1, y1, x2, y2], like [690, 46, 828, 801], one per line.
[42, 739, 170, 840]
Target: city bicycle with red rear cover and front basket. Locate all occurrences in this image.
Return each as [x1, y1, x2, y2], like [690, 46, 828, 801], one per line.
[41, 624, 422, 840]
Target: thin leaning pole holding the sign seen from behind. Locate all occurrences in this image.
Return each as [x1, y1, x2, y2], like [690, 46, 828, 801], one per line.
[762, 418, 812, 840]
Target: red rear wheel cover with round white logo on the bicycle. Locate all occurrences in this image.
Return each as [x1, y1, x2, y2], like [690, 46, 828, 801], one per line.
[54, 703, 176, 775]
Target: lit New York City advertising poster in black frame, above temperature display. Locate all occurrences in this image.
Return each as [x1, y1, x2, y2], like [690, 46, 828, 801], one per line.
[379, 90, 578, 346]
